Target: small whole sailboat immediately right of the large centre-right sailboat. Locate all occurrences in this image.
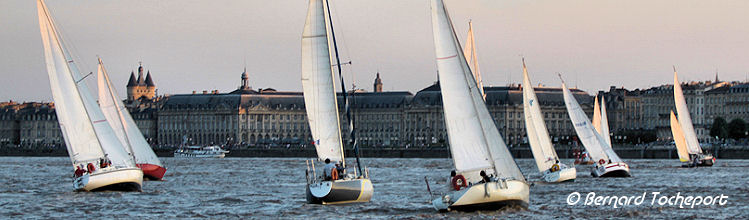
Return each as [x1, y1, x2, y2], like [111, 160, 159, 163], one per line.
[523, 59, 577, 183]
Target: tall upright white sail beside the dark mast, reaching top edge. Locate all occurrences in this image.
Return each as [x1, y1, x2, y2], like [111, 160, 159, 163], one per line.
[302, 0, 343, 161]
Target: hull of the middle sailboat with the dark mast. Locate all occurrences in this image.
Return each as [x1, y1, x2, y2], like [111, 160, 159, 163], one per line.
[307, 179, 374, 205]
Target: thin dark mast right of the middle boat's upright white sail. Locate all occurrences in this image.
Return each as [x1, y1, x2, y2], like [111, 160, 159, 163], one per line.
[325, 0, 362, 174]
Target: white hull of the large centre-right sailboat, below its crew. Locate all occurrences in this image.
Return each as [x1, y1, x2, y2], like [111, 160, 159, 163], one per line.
[432, 180, 530, 211]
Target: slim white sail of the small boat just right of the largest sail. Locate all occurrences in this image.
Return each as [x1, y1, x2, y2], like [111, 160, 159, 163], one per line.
[523, 60, 558, 172]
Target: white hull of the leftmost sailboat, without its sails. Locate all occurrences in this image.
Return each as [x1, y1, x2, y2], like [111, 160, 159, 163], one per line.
[73, 168, 143, 192]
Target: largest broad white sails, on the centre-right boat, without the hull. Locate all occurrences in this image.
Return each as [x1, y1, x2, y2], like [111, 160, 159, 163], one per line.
[432, 0, 524, 181]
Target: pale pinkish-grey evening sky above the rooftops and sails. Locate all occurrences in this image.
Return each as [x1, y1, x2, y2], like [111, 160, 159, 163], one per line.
[0, 0, 749, 101]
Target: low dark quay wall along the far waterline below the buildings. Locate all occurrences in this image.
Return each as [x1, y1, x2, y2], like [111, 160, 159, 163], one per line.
[0, 146, 749, 159]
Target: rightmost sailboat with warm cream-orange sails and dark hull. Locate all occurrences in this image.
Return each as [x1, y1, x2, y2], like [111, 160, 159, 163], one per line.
[671, 67, 715, 167]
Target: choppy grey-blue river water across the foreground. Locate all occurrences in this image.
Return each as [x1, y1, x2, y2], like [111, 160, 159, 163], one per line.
[0, 157, 749, 219]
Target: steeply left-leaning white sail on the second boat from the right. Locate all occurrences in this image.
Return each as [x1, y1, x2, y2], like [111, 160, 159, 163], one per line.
[562, 82, 613, 162]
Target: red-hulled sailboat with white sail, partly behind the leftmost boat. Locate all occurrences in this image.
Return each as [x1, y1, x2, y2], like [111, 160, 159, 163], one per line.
[97, 59, 166, 180]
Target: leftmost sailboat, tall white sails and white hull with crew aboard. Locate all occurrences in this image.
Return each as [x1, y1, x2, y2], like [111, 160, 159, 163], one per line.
[37, 0, 143, 191]
